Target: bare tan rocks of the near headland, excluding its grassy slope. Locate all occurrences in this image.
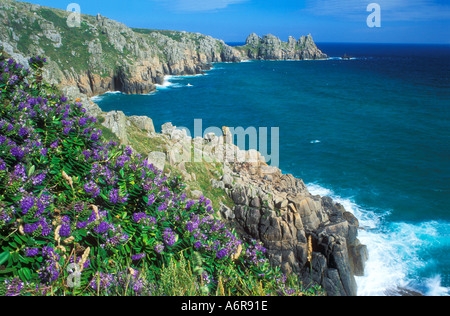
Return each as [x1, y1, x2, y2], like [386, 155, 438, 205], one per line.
[156, 123, 368, 296]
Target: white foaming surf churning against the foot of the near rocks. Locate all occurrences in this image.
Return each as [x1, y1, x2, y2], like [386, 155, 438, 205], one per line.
[307, 183, 450, 296]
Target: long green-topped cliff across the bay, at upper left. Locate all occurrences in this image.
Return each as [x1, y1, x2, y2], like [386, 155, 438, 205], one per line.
[0, 0, 241, 96]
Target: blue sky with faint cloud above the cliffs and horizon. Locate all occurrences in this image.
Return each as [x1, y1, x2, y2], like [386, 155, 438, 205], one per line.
[21, 0, 450, 44]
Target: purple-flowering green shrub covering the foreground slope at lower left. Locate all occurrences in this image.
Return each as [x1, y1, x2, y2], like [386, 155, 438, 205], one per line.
[0, 51, 320, 295]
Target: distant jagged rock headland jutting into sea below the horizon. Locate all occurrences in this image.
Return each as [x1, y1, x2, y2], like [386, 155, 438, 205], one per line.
[237, 33, 328, 60]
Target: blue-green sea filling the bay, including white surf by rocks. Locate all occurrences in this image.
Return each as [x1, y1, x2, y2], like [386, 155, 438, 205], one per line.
[94, 43, 450, 296]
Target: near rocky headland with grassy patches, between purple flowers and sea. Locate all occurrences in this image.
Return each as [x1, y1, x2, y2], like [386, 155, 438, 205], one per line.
[90, 107, 368, 296]
